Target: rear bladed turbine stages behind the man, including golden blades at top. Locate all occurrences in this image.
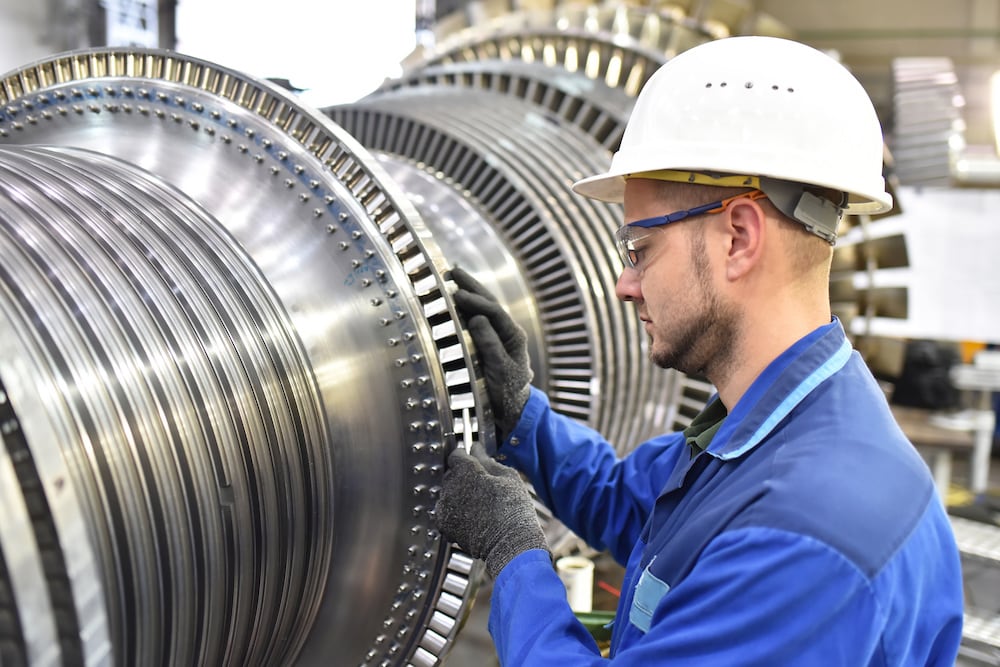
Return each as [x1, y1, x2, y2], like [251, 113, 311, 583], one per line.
[374, 3, 744, 453]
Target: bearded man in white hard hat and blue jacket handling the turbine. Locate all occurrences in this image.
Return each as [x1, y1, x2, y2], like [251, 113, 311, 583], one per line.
[436, 37, 963, 667]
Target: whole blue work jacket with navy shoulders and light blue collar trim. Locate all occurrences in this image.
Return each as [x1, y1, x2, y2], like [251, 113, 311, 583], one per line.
[489, 320, 963, 667]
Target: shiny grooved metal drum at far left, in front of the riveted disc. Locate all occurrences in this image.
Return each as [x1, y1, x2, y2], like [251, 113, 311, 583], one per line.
[0, 148, 333, 664]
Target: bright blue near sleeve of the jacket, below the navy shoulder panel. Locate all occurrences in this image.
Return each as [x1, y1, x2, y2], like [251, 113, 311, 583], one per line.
[490, 529, 891, 667]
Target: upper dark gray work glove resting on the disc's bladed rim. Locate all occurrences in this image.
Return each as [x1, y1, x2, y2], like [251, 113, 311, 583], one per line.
[451, 267, 533, 442]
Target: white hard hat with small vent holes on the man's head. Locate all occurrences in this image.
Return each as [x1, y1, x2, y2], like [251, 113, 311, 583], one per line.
[573, 37, 892, 218]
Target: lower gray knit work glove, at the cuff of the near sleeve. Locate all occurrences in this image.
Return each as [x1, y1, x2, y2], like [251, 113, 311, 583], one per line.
[434, 443, 548, 579]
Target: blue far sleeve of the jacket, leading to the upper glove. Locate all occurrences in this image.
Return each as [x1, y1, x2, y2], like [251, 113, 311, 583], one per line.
[498, 387, 685, 563]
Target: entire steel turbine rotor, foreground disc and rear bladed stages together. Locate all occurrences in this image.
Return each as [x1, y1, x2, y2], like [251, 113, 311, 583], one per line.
[0, 1, 908, 667]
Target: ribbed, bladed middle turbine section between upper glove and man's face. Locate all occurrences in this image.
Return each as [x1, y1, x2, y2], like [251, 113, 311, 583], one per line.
[326, 85, 676, 447]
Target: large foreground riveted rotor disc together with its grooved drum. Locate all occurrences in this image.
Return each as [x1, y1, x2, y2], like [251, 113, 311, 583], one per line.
[0, 49, 484, 665]
